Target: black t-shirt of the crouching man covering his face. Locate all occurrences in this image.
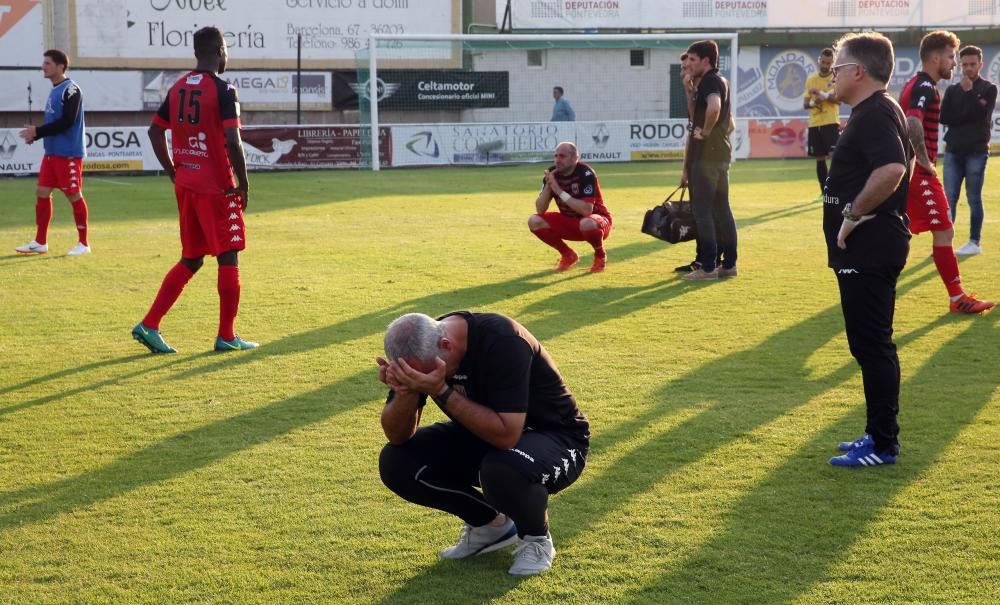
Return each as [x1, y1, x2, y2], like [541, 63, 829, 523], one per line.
[440, 311, 590, 442]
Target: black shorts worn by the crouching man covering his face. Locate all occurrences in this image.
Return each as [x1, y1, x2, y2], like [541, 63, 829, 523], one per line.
[401, 422, 589, 494]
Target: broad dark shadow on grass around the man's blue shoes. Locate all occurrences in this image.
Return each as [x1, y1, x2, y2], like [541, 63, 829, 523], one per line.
[632, 317, 1000, 603]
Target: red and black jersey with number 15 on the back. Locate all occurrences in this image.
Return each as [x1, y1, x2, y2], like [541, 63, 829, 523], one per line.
[153, 71, 240, 193]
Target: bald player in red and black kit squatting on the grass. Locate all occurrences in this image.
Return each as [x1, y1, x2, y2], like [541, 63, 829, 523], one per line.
[528, 142, 611, 273]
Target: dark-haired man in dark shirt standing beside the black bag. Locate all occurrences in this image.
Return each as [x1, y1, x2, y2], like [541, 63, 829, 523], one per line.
[682, 40, 737, 280]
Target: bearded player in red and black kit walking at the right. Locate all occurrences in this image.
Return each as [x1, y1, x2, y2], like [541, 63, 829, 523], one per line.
[899, 31, 993, 313]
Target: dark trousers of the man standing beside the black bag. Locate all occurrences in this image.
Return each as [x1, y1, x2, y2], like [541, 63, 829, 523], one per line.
[689, 161, 736, 272]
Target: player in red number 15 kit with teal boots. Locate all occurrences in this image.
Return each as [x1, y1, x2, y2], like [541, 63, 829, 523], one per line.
[132, 27, 258, 353]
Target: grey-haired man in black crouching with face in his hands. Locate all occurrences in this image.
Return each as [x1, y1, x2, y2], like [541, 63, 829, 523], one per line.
[376, 311, 590, 576]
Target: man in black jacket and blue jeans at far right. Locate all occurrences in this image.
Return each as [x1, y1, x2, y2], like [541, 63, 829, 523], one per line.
[941, 45, 997, 256]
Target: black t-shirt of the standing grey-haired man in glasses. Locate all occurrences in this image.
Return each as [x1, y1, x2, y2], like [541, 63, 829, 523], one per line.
[823, 91, 913, 269]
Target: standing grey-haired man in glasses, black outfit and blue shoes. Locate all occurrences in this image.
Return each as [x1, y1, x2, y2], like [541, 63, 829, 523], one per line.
[823, 33, 913, 467]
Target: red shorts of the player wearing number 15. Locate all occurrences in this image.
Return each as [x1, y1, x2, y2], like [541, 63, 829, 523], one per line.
[174, 187, 247, 258]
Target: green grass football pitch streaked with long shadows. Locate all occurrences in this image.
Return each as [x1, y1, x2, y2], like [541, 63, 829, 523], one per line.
[0, 161, 1000, 605]
